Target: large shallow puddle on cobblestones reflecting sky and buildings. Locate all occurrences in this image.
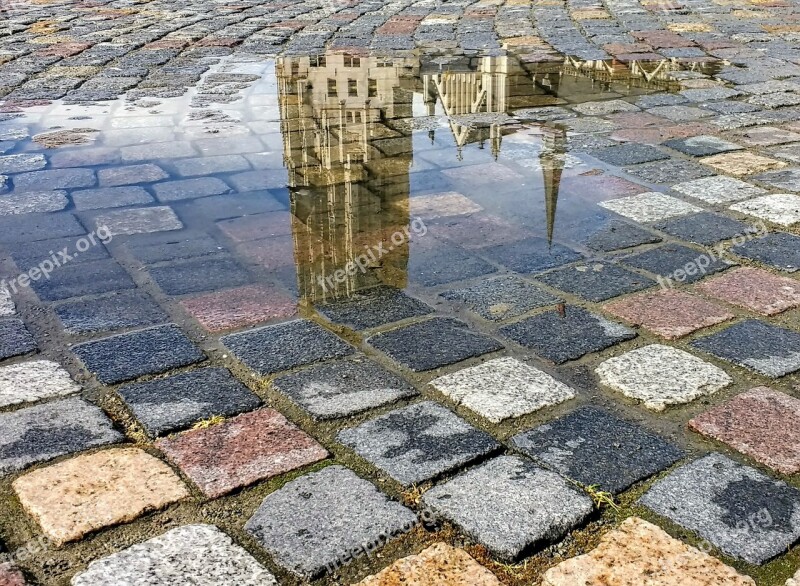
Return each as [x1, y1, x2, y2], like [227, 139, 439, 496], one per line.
[0, 52, 716, 304]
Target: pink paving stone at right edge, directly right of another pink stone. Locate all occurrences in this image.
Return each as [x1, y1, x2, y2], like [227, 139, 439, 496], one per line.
[697, 267, 800, 315]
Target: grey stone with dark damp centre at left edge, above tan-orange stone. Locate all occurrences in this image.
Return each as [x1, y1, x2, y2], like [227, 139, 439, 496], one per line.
[0, 397, 124, 476]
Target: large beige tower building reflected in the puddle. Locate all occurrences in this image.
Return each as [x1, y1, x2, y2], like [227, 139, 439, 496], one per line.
[276, 53, 417, 303]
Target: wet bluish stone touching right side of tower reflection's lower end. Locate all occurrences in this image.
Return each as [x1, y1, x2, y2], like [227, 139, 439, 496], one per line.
[408, 237, 497, 287]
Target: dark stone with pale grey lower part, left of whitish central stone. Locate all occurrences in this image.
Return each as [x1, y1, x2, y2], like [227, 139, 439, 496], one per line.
[272, 357, 417, 420]
